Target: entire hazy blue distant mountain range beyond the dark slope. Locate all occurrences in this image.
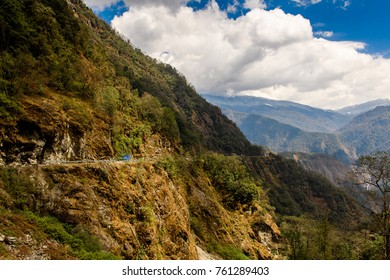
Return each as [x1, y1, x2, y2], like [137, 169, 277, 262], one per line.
[204, 95, 390, 163]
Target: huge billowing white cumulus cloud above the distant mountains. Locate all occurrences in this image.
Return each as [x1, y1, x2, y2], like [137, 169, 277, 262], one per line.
[112, 1, 390, 108]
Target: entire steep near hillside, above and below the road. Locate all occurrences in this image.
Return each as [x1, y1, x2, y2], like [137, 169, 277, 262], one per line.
[0, 0, 368, 259]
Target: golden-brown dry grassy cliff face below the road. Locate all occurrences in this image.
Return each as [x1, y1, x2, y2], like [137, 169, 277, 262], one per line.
[0, 161, 280, 259]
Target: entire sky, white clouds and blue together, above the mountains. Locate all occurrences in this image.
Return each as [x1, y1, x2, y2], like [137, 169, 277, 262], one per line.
[84, 0, 390, 109]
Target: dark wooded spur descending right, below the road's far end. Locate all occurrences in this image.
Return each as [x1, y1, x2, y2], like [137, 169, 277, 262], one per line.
[252, 154, 361, 224]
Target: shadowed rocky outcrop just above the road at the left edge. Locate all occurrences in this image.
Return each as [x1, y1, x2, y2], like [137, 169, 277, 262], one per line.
[0, 97, 114, 165]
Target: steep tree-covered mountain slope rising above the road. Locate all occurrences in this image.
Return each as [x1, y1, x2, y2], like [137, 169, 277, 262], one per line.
[0, 0, 261, 166]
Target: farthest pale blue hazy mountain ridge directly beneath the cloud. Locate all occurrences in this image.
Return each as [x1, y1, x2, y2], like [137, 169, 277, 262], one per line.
[203, 95, 350, 132]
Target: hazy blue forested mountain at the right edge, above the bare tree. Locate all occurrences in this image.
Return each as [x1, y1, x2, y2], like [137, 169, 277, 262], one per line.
[338, 106, 390, 155]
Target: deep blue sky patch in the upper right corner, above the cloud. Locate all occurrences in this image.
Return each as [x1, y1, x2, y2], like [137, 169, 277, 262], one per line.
[270, 0, 390, 56]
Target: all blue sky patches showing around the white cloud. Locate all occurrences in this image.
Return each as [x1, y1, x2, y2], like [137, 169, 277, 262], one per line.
[95, 0, 390, 57]
